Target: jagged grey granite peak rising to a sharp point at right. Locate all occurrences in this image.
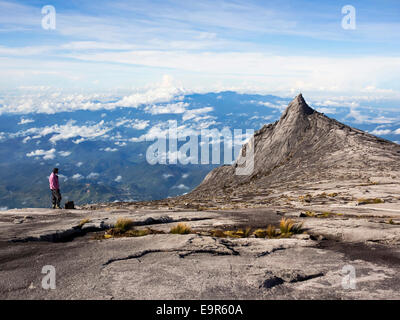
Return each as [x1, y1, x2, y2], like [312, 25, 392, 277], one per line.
[186, 94, 400, 199]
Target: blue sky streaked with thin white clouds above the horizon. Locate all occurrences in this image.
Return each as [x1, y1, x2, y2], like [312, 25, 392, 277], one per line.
[0, 0, 400, 105]
